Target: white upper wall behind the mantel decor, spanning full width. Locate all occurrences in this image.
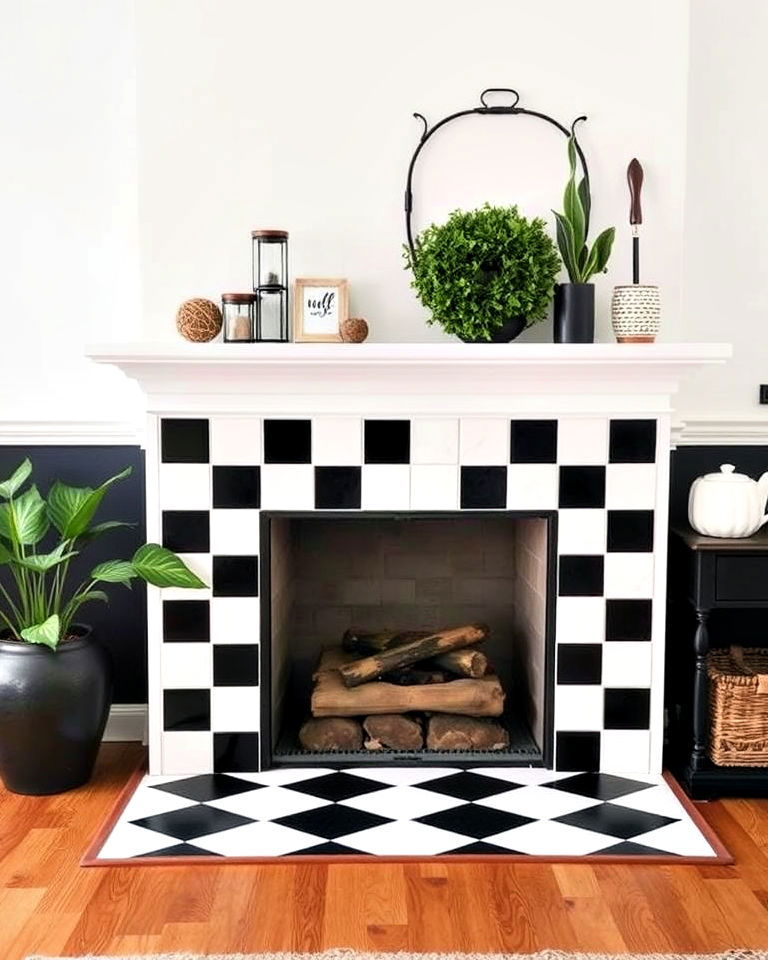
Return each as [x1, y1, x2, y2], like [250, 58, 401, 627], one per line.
[7, 0, 756, 428]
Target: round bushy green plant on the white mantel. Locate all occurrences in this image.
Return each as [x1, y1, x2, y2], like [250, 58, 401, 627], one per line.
[405, 204, 560, 343]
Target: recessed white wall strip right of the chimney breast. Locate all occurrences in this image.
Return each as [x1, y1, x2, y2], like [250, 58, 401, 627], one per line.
[681, 0, 768, 424]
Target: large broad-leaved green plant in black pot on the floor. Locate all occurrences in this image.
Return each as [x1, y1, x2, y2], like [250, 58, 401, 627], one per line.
[0, 460, 205, 794]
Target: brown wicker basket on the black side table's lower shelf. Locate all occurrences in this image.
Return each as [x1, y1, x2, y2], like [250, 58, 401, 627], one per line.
[707, 647, 768, 767]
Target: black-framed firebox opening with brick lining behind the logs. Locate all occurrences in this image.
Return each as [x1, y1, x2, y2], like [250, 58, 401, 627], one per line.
[261, 511, 556, 769]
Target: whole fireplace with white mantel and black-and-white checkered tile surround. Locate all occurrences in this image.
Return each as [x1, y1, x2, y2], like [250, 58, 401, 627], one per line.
[91, 343, 730, 778]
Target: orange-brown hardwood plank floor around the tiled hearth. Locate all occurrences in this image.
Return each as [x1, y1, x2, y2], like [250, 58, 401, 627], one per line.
[0, 744, 768, 960]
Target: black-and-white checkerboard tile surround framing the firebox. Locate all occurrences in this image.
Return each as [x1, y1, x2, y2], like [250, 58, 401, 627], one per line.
[155, 416, 660, 774]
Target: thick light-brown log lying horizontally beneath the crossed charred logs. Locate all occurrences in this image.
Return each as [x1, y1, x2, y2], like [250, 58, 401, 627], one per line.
[312, 647, 504, 717]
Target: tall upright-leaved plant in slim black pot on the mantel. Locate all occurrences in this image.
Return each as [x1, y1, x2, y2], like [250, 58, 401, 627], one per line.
[552, 135, 616, 343]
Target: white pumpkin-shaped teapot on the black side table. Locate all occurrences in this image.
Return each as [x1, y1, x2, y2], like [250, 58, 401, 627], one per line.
[688, 463, 768, 537]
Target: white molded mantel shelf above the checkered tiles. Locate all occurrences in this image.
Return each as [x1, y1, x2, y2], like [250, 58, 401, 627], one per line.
[88, 343, 731, 414]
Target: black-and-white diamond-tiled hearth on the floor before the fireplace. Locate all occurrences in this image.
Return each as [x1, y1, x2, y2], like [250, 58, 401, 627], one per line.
[84, 767, 723, 865]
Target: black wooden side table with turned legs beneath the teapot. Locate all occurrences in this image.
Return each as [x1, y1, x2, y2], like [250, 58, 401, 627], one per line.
[665, 527, 768, 799]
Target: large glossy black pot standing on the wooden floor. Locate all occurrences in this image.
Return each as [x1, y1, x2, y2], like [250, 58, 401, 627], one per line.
[0, 626, 112, 796]
